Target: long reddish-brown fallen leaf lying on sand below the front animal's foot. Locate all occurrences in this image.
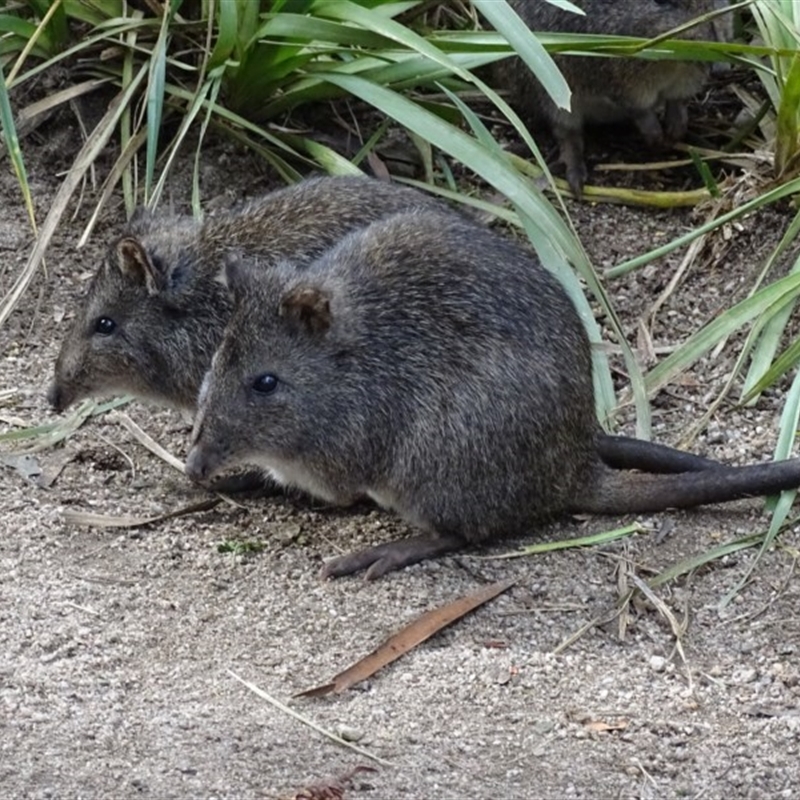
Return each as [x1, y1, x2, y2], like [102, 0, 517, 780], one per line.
[295, 578, 516, 697]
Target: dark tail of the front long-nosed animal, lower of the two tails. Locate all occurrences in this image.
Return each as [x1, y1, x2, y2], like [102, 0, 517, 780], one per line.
[571, 458, 800, 514]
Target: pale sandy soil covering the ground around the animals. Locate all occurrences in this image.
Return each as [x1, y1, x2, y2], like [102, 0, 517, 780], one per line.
[0, 101, 800, 800]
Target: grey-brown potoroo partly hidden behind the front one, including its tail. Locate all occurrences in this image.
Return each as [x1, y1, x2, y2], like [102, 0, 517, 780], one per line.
[48, 178, 714, 472]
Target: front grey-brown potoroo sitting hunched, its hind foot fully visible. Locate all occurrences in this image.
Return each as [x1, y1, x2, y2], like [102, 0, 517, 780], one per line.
[187, 212, 800, 578]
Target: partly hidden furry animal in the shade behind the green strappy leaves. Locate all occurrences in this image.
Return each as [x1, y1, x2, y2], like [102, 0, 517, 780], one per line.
[497, 0, 731, 196]
